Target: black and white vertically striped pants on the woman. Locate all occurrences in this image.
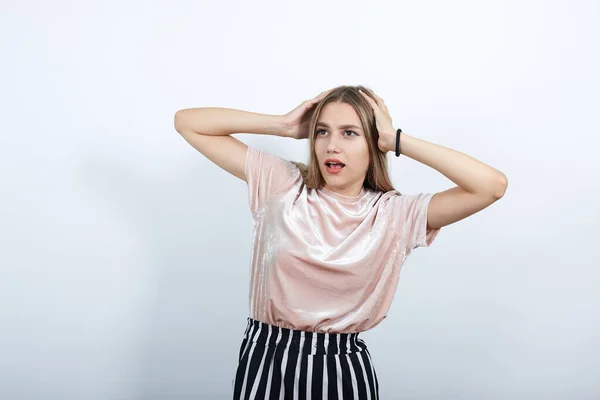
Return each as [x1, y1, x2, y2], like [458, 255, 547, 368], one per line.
[233, 318, 379, 400]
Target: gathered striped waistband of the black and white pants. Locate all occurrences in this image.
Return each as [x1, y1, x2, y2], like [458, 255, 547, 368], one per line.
[244, 318, 367, 355]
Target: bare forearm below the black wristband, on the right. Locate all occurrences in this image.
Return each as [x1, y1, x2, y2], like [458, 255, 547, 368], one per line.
[400, 133, 507, 197]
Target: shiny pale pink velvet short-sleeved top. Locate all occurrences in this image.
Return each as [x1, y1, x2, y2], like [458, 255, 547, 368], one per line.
[244, 146, 439, 333]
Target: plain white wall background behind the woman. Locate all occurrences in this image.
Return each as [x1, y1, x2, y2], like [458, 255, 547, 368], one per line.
[0, 0, 600, 400]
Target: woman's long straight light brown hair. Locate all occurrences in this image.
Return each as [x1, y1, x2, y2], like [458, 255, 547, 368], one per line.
[292, 85, 395, 193]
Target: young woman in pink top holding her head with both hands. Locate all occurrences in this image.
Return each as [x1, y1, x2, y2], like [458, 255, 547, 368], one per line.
[175, 86, 507, 400]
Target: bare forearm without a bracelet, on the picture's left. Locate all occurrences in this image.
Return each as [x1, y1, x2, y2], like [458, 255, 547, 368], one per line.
[175, 107, 285, 136]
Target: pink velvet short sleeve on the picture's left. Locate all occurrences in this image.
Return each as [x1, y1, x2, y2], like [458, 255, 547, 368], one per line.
[244, 146, 300, 215]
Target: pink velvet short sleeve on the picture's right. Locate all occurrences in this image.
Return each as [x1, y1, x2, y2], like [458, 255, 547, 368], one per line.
[395, 193, 440, 253]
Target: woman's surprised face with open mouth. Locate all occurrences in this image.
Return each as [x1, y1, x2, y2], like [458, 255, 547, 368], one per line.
[314, 102, 369, 196]
